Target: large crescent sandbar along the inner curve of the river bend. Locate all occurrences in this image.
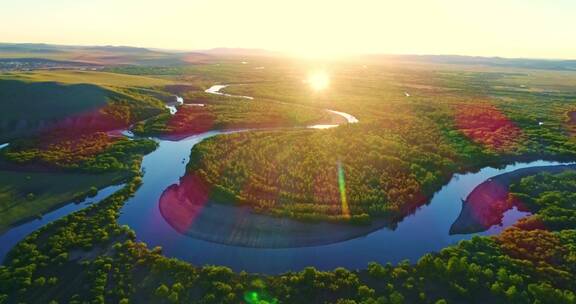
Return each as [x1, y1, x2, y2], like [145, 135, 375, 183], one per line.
[159, 175, 390, 248]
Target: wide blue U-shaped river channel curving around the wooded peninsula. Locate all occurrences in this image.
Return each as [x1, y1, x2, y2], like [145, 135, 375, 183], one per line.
[119, 131, 560, 273]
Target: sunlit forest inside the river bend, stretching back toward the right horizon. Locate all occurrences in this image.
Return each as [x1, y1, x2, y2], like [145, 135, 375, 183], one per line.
[183, 68, 576, 223]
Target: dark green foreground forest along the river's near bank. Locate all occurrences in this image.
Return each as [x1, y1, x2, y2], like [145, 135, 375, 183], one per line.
[0, 166, 576, 304]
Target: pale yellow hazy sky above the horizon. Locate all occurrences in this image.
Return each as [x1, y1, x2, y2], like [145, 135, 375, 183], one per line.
[0, 0, 576, 58]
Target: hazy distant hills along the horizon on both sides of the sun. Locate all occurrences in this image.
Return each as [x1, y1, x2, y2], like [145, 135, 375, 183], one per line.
[0, 43, 576, 71]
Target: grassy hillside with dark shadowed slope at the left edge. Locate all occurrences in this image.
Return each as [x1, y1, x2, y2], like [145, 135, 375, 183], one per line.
[0, 71, 172, 141]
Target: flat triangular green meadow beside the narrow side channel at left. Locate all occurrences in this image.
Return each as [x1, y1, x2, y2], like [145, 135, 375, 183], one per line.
[0, 170, 128, 233]
